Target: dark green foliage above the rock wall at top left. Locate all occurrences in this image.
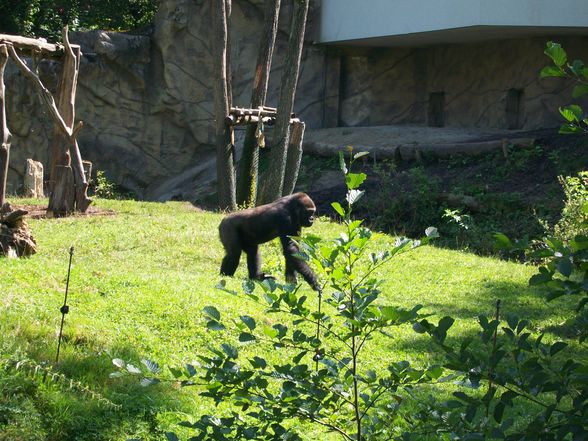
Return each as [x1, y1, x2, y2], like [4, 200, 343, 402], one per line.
[0, 0, 157, 41]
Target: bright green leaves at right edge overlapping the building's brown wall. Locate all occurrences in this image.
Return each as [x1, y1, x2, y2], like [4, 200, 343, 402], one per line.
[540, 41, 588, 133]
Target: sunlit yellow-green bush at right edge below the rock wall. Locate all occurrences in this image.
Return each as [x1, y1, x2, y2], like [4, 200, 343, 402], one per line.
[555, 171, 588, 242]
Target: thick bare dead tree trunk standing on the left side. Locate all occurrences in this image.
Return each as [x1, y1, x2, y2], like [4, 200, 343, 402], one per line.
[48, 27, 92, 215]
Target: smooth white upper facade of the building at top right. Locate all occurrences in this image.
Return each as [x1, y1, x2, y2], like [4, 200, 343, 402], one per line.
[318, 0, 588, 44]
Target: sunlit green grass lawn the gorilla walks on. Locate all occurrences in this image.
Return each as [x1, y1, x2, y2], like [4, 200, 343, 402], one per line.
[0, 200, 580, 440]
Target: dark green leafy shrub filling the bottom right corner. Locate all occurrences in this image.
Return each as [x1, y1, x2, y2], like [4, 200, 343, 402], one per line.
[414, 306, 588, 441]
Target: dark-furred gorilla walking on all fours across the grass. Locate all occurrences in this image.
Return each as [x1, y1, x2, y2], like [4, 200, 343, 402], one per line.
[218, 193, 320, 291]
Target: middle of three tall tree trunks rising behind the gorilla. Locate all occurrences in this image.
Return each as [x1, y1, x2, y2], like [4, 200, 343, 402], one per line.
[237, 0, 281, 207]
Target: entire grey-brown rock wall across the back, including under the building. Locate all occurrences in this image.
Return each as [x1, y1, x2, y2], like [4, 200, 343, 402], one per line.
[6, 0, 588, 200]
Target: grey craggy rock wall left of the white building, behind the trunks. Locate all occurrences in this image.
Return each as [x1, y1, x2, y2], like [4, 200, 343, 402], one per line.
[6, 0, 325, 200]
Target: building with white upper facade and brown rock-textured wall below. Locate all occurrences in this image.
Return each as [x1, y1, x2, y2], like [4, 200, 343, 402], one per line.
[316, 0, 588, 129]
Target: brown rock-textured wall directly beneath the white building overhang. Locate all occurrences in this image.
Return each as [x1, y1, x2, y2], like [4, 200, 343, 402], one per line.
[329, 36, 588, 130]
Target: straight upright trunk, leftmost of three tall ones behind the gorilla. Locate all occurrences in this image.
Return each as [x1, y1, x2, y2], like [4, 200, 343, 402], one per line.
[211, 0, 237, 210]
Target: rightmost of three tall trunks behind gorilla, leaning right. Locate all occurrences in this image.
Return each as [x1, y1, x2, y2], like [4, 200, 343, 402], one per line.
[260, 0, 309, 204]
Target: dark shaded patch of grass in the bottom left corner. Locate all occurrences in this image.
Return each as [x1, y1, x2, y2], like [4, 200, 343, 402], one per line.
[0, 347, 183, 441]
